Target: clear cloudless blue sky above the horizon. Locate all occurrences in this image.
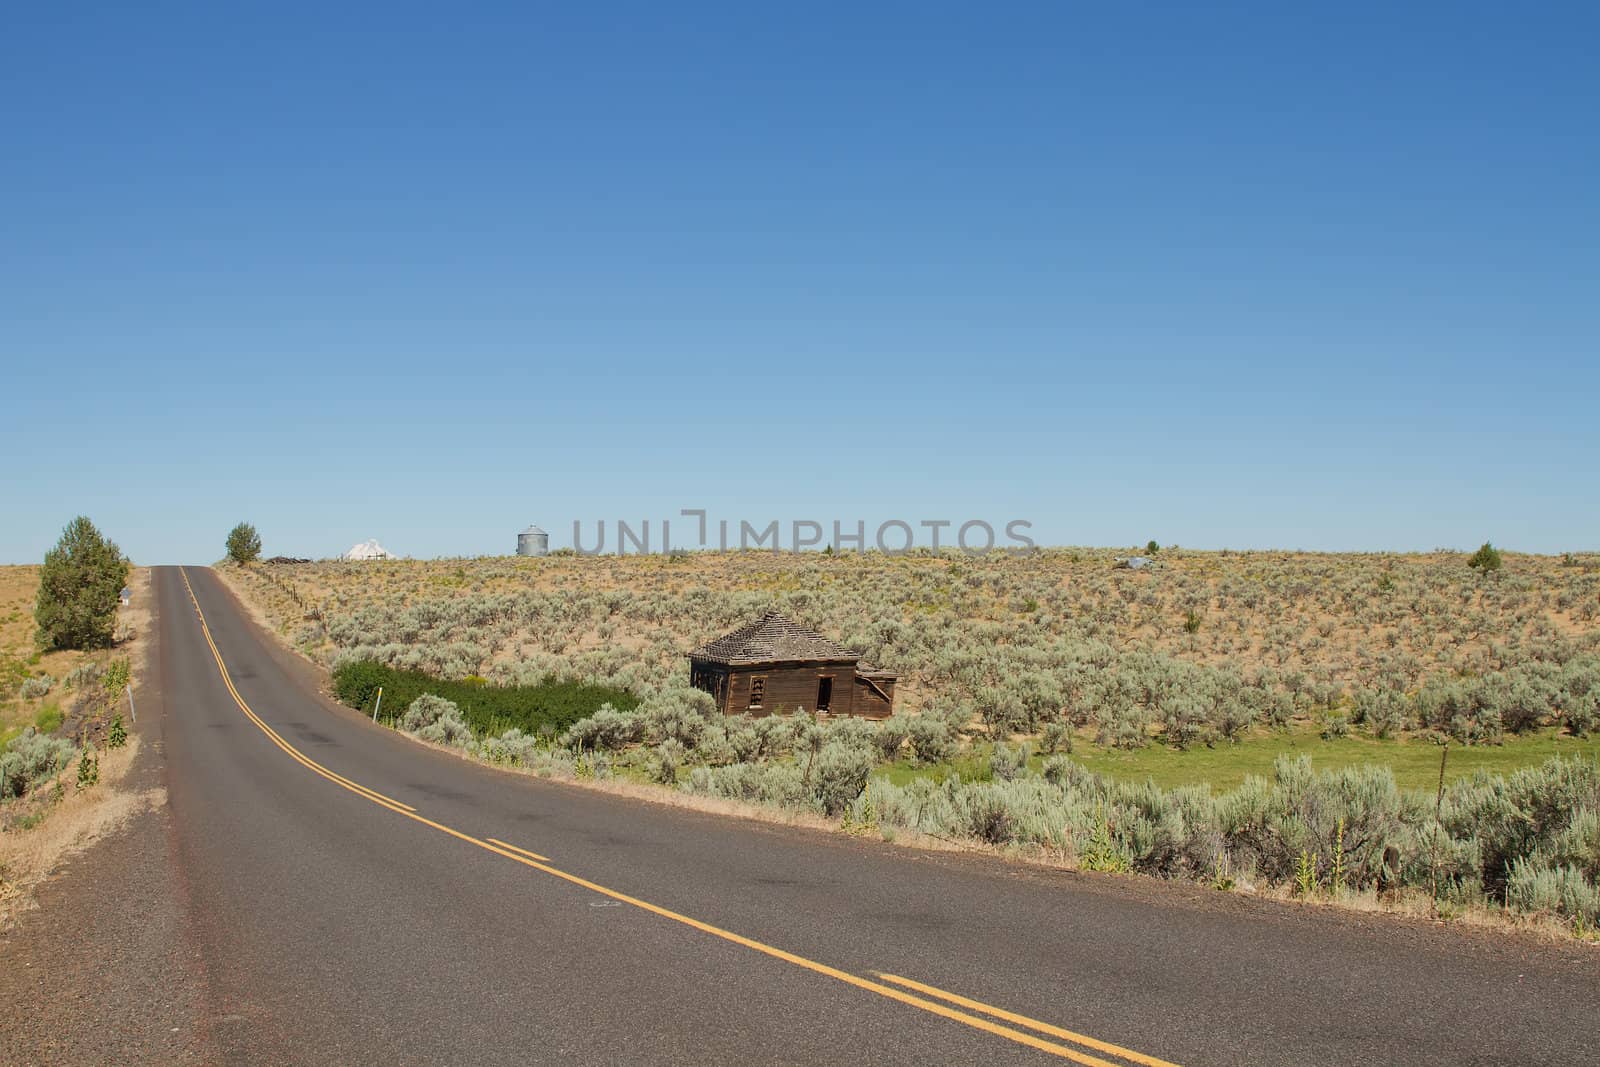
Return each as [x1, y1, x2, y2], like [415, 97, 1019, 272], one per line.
[0, 3, 1600, 563]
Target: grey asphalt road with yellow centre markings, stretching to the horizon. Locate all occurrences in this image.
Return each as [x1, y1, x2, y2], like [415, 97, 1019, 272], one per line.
[15, 568, 1600, 1065]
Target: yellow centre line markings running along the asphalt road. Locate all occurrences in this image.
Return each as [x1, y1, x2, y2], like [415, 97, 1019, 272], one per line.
[178, 568, 1178, 1067]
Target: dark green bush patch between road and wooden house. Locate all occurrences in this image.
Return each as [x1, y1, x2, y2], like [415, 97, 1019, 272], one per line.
[333, 661, 638, 737]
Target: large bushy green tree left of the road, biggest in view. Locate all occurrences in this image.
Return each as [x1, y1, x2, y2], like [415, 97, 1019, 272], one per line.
[34, 515, 128, 648]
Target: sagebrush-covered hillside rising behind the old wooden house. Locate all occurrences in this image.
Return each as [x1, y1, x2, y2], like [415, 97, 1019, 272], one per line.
[216, 549, 1600, 769]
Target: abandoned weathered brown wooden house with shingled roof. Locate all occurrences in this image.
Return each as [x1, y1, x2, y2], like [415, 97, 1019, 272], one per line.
[690, 611, 894, 718]
